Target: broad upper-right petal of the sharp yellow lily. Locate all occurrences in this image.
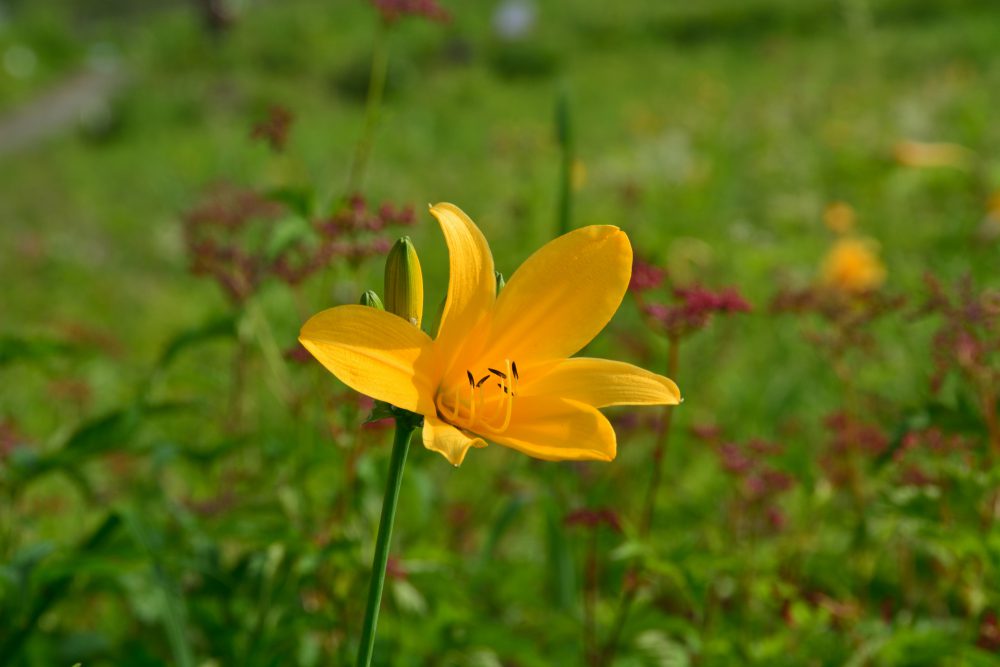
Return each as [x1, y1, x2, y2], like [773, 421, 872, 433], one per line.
[483, 225, 632, 366]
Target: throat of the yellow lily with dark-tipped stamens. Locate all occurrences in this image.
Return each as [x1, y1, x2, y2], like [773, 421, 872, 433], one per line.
[434, 359, 518, 433]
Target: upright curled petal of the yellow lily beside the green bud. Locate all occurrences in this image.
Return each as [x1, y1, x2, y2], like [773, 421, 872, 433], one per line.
[431, 203, 496, 371]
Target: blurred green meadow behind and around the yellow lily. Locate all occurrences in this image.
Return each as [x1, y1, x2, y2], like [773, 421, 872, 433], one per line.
[0, 0, 1000, 666]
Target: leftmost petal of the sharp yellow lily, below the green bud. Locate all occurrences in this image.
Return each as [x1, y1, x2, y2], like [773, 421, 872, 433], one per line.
[299, 306, 434, 414]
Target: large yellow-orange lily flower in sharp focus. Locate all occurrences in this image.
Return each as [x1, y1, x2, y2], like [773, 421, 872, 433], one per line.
[299, 204, 680, 466]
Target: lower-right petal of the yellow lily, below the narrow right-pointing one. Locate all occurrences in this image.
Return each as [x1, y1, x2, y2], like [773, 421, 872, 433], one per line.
[484, 396, 617, 461]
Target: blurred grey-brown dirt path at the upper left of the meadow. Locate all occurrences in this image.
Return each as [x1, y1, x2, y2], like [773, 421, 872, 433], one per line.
[0, 69, 125, 160]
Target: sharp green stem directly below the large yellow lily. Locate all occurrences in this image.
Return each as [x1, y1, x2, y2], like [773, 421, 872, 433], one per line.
[358, 417, 414, 667]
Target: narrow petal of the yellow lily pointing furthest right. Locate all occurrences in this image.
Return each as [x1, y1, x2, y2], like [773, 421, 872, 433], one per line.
[518, 357, 681, 408]
